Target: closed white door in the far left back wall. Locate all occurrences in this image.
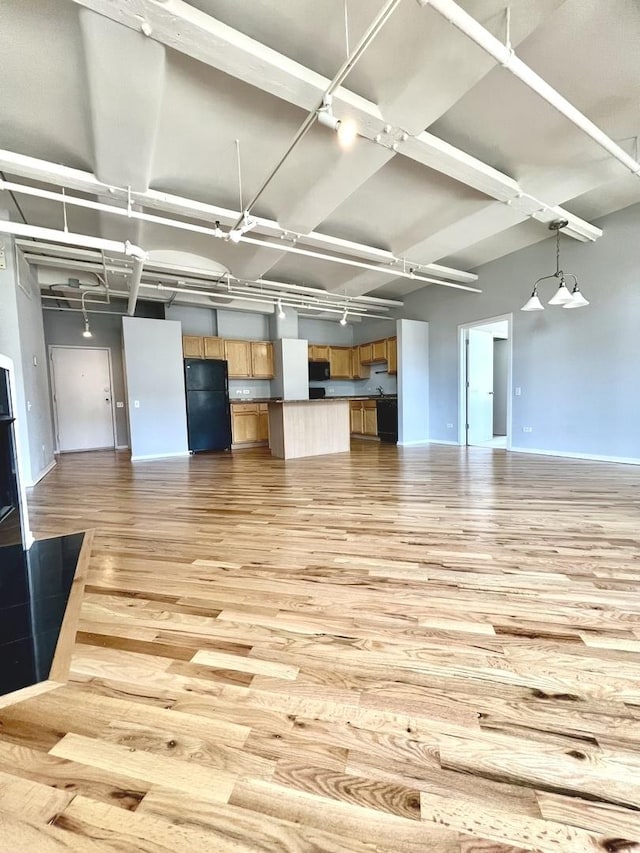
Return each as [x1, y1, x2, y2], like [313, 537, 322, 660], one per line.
[51, 347, 115, 453]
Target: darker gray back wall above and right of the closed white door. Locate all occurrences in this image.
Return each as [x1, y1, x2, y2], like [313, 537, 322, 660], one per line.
[42, 303, 129, 447]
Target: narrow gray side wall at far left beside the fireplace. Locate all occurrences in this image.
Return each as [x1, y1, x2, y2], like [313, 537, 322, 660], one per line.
[0, 236, 54, 486]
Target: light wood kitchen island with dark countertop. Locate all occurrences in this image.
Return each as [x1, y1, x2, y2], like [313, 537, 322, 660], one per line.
[269, 397, 351, 459]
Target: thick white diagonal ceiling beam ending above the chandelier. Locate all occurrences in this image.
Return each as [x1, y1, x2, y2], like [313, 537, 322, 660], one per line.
[73, 0, 602, 240]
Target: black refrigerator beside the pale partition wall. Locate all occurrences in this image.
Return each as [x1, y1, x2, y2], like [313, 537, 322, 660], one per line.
[184, 358, 231, 453]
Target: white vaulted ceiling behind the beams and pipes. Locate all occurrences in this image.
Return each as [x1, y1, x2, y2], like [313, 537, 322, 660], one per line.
[0, 0, 640, 312]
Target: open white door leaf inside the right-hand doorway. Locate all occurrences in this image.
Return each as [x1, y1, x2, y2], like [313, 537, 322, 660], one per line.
[467, 329, 493, 444]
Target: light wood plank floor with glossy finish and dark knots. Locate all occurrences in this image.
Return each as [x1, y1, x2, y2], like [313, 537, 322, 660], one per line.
[0, 442, 640, 853]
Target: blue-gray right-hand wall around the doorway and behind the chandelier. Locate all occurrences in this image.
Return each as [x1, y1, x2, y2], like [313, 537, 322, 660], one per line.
[405, 205, 640, 460]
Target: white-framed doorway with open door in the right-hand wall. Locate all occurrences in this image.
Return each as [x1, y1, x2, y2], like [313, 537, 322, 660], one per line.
[458, 314, 513, 450]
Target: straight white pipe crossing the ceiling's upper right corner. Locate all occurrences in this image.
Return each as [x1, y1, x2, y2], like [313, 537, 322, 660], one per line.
[418, 0, 640, 176]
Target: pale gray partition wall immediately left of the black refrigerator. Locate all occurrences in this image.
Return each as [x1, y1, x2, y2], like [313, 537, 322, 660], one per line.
[122, 317, 189, 460]
